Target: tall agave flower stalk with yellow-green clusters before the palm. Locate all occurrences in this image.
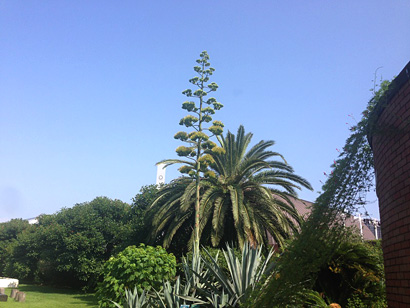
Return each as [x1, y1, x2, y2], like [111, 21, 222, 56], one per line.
[158, 51, 224, 252]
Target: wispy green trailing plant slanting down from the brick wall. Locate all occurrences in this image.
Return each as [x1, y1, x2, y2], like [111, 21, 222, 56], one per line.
[250, 82, 389, 307]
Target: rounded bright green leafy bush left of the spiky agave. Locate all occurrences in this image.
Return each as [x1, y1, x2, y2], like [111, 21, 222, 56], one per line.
[97, 244, 176, 307]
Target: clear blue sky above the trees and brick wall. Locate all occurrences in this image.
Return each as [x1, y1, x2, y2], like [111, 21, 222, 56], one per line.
[0, 0, 410, 221]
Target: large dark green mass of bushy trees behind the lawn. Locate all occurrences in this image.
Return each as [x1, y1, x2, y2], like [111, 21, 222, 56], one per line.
[5, 197, 131, 288]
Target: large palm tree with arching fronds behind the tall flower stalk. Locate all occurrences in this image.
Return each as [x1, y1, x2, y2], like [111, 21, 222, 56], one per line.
[152, 126, 312, 247]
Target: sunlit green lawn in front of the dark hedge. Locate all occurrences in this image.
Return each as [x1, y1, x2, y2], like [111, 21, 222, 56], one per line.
[0, 284, 98, 308]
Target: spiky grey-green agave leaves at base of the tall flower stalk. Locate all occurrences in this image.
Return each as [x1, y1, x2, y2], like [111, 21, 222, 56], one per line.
[135, 243, 273, 308]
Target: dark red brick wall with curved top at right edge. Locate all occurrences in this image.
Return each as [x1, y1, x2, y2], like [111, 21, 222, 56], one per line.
[371, 72, 410, 307]
